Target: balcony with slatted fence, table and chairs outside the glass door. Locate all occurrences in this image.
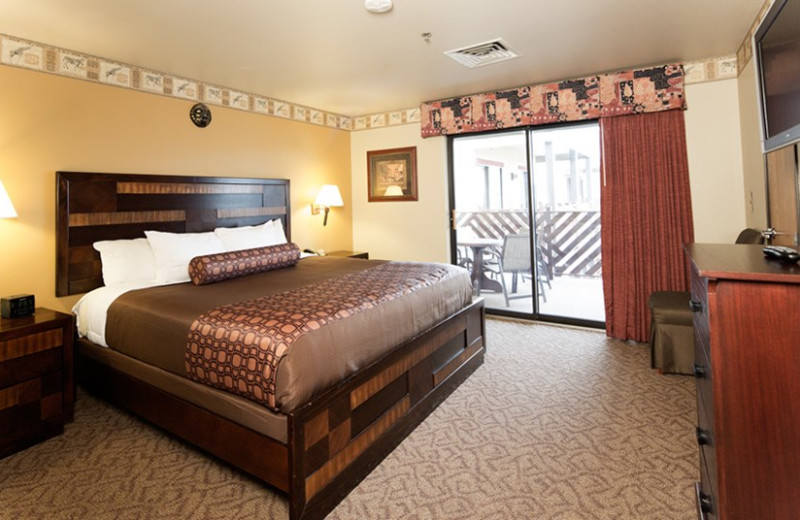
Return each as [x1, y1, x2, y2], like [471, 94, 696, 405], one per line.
[455, 210, 605, 322]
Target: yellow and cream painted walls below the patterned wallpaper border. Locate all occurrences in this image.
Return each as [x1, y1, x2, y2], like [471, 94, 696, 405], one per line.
[0, 65, 765, 310]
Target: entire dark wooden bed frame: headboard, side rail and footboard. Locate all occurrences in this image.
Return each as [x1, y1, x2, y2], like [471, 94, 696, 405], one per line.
[56, 172, 485, 520]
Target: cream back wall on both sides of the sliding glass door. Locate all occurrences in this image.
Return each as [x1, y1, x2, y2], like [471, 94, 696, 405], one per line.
[351, 80, 745, 262]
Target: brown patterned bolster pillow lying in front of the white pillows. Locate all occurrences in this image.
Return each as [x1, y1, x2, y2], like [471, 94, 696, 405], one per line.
[189, 243, 300, 285]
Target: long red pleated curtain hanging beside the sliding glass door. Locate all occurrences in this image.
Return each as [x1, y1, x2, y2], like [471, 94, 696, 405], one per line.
[600, 110, 694, 341]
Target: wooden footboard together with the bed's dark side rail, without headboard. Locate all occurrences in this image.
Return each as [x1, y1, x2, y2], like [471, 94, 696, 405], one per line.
[78, 300, 485, 520]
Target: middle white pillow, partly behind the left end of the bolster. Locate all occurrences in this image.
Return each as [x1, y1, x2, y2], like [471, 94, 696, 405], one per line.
[144, 231, 225, 283]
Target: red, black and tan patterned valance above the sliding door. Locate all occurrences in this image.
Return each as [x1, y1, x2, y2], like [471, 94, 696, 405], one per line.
[420, 64, 686, 137]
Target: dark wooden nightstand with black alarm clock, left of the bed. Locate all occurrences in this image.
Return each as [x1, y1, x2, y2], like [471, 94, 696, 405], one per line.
[0, 307, 75, 457]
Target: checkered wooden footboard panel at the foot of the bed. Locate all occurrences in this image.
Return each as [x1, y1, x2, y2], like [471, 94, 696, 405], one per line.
[290, 300, 485, 520]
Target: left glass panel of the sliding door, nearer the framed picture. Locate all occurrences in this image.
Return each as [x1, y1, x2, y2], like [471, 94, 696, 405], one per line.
[451, 130, 534, 314]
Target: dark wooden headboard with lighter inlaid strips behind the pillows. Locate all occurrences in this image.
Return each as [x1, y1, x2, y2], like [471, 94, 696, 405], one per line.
[56, 172, 291, 296]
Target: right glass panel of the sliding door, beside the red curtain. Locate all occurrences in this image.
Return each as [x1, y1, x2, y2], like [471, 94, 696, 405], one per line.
[530, 123, 605, 323]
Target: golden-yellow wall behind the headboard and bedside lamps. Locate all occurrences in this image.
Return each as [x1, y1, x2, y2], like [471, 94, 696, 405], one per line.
[0, 66, 353, 310]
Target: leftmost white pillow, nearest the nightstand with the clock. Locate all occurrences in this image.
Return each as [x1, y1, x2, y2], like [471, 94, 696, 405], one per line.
[92, 238, 156, 286]
